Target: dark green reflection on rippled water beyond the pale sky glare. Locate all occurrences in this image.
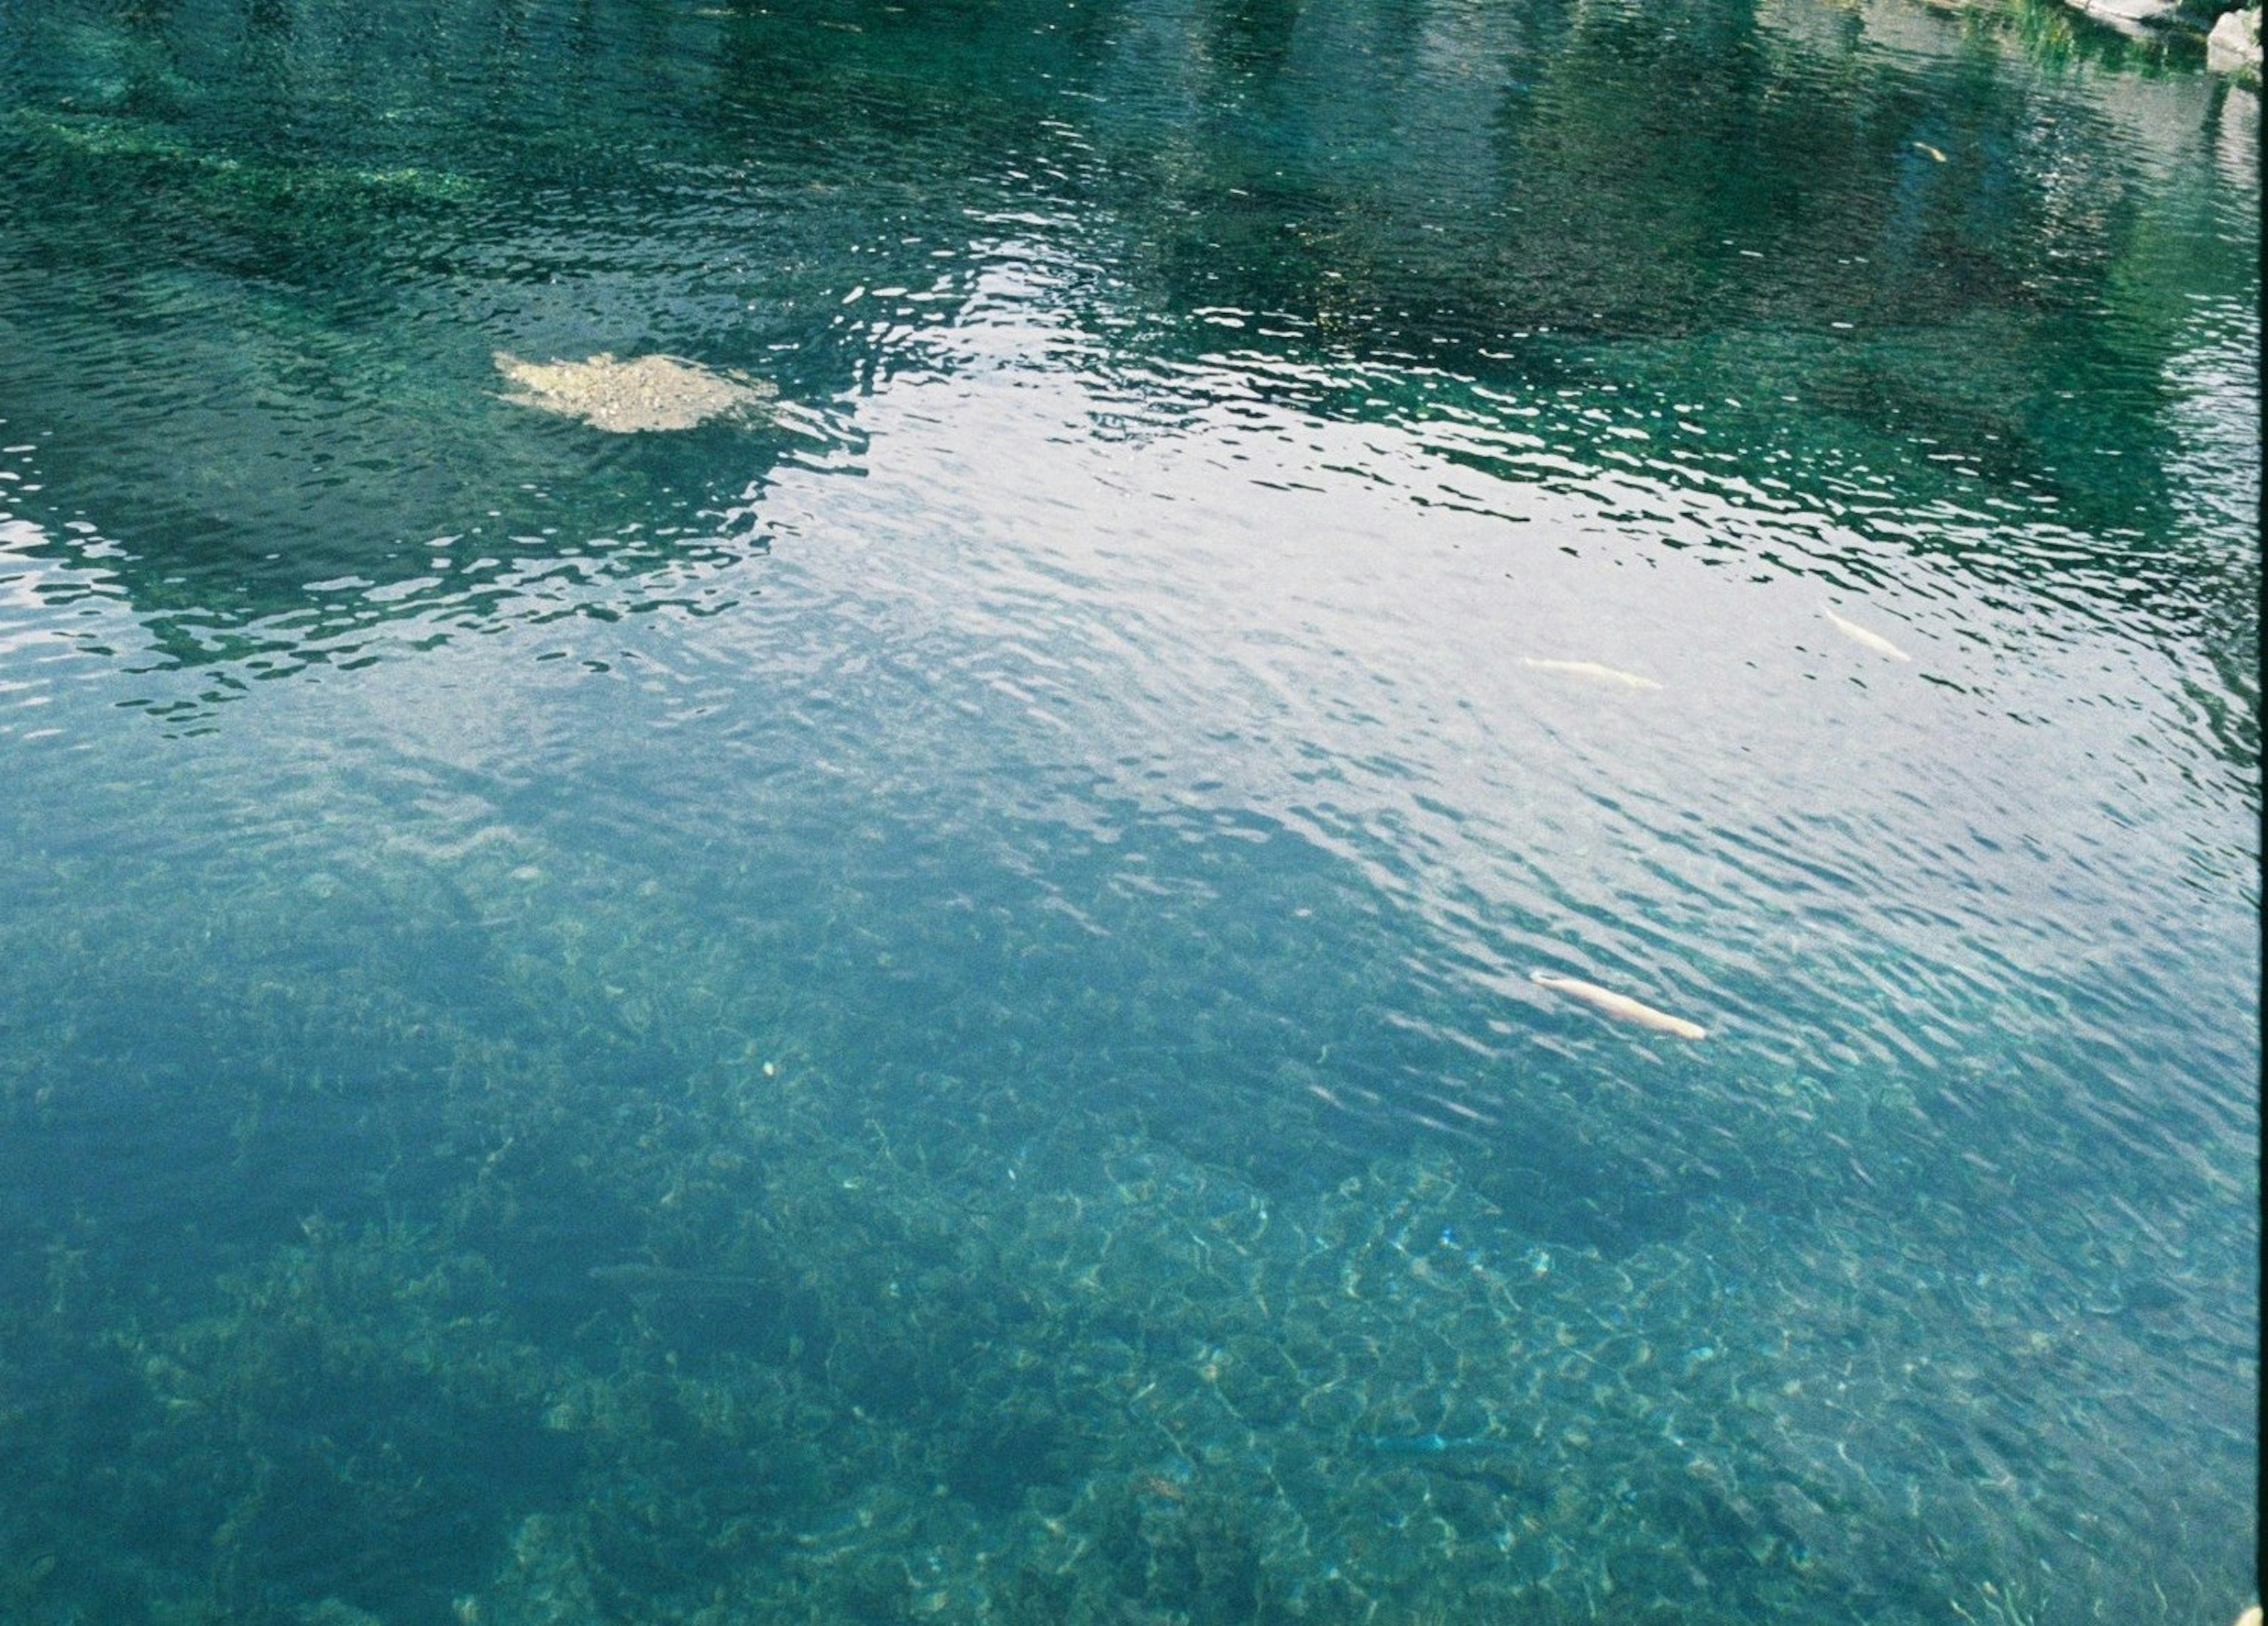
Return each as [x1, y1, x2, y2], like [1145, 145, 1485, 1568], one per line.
[0, 5, 2257, 662]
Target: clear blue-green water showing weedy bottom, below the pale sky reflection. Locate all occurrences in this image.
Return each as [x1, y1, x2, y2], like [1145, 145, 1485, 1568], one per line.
[0, 775, 2250, 1626]
